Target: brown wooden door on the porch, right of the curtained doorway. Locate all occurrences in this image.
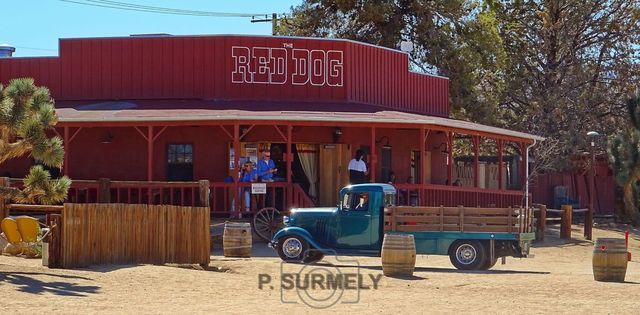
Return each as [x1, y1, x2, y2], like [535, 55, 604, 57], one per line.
[318, 144, 351, 207]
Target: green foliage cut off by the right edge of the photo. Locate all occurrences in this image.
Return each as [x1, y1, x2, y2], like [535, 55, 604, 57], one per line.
[607, 94, 640, 225]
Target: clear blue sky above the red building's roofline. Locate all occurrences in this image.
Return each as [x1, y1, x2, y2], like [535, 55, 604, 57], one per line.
[0, 0, 302, 57]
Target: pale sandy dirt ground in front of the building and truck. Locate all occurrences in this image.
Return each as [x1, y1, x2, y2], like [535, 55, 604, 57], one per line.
[0, 226, 640, 314]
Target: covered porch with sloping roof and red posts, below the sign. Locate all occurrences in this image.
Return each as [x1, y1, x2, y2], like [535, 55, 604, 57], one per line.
[9, 101, 541, 215]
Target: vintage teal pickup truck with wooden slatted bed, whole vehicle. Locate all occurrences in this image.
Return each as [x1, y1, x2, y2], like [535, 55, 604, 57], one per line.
[269, 184, 535, 270]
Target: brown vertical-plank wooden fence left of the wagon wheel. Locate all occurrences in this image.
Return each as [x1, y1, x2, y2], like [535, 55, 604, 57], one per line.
[59, 203, 210, 268]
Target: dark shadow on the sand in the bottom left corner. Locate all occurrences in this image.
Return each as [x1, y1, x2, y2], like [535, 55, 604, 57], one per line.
[0, 272, 100, 297]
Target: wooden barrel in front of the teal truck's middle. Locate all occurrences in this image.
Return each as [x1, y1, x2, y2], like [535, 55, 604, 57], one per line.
[382, 234, 416, 276]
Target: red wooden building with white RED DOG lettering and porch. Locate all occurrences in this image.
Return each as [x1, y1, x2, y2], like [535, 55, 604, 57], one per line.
[0, 35, 542, 217]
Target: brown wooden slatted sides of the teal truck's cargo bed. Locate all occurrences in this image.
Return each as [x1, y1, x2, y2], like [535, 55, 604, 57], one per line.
[384, 207, 533, 233]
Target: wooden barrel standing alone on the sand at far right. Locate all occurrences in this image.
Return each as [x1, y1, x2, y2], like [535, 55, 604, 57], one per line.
[593, 238, 627, 282]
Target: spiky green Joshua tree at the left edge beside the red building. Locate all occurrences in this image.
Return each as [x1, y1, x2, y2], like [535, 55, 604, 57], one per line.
[0, 78, 71, 204]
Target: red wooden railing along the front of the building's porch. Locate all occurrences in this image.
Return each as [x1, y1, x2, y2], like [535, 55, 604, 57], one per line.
[10, 178, 531, 215]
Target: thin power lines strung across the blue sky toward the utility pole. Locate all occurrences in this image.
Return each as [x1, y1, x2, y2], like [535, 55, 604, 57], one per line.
[58, 0, 266, 17]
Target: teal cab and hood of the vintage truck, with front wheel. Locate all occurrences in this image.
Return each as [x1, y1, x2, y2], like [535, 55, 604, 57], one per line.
[271, 184, 396, 262]
